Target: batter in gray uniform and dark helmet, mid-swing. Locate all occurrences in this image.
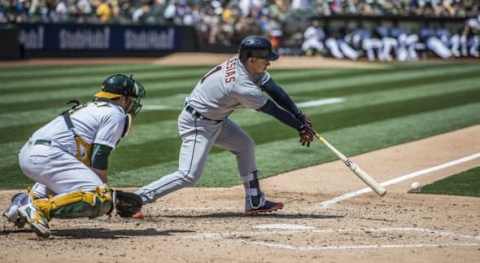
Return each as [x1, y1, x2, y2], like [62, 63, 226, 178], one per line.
[136, 36, 314, 214]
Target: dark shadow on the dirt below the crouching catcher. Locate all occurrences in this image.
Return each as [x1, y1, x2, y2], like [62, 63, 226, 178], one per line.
[52, 228, 195, 239]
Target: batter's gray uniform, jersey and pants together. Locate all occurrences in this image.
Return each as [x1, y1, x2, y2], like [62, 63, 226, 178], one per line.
[136, 57, 270, 203]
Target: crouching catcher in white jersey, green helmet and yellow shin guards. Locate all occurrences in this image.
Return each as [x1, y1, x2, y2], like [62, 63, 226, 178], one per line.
[3, 74, 145, 237]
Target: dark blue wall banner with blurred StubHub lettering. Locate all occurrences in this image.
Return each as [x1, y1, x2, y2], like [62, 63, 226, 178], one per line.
[10, 23, 198, 58]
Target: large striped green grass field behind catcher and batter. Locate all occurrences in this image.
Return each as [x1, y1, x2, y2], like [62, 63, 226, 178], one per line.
[0, 63, 480, 188]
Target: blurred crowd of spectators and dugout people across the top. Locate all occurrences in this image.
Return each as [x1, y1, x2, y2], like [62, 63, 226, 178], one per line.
[0, 0, 480, 60]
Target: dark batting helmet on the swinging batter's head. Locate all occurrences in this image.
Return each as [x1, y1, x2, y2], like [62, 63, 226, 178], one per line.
[238, 36, 279, 61]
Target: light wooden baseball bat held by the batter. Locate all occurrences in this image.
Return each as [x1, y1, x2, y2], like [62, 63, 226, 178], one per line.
[315, 132, 387, 196]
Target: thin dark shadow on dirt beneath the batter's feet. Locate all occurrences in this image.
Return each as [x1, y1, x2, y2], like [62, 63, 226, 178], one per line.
[160, 212, 345, 219]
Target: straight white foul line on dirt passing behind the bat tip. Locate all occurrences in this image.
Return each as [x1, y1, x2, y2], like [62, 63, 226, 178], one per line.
[320, 153, 480, 208]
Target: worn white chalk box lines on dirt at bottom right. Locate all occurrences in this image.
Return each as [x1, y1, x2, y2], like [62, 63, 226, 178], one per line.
[184, 227, 480, 251]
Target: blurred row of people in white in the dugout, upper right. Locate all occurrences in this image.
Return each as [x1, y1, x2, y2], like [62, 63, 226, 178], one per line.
[302, 15, 480, 61]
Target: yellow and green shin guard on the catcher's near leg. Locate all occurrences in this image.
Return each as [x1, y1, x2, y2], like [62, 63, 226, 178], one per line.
[33, 186, 113, 220]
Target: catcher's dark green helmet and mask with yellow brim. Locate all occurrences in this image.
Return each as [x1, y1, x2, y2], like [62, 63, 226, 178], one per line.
[95, 74, 145, 115]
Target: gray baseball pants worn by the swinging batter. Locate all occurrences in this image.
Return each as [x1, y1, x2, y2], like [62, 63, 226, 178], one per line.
[136, 110, 257, 203]
